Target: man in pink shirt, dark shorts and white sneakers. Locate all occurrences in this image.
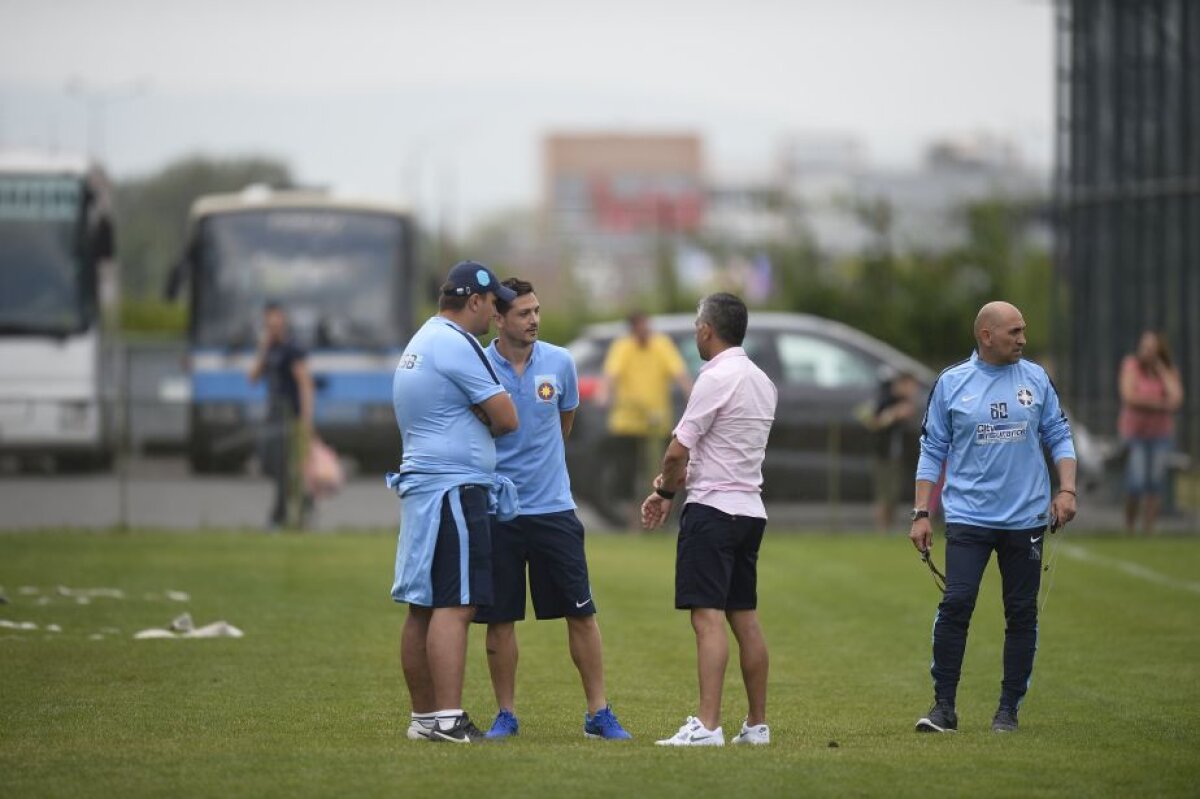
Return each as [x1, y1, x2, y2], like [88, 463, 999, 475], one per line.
[642, 294, 778, 746]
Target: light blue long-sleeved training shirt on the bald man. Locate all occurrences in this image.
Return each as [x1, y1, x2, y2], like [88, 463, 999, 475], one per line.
[917, 353, 1075, 530]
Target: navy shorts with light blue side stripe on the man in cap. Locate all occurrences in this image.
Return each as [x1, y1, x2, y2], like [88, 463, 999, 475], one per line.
[430, 486, 492, 607]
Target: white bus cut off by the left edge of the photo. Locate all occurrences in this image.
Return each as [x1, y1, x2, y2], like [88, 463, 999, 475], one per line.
[0, 152, 116, 468]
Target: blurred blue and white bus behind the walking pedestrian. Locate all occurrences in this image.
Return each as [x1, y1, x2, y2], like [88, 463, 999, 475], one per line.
[168, 187, 415, 471]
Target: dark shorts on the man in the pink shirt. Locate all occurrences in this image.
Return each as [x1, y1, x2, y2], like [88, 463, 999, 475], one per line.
[676, 503, 767, 611]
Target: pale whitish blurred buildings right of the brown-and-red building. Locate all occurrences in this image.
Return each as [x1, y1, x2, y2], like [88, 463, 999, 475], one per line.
[704, 133, 1050, 258]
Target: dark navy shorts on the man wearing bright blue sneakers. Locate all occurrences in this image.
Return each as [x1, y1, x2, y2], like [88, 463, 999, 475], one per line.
[475, 511, 596, 624]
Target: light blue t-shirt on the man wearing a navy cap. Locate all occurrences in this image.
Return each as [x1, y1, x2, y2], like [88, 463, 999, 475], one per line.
[391, 317, 504, 475]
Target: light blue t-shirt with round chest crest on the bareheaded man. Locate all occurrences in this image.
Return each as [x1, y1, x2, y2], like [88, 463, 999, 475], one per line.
[487, 333, 580, 515]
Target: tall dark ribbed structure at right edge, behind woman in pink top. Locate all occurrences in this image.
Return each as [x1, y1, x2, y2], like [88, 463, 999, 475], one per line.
[1054, 0, 1200, 456]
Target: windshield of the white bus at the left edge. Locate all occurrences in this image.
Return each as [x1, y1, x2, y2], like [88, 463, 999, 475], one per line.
[0, 174, 84, 335]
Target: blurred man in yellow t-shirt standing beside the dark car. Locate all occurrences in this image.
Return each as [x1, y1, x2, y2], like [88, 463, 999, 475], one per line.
[604, 312, 691, 529]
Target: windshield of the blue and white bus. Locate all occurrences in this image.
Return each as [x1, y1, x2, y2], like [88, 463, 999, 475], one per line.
[192, 209, 407, 348]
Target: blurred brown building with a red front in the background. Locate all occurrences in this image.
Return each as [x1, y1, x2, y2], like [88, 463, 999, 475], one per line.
[542, 132, 704, 305]
